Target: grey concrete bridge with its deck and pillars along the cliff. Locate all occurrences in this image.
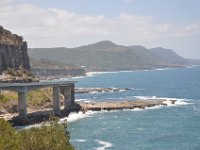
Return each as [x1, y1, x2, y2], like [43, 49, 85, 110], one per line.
[0, 81, 75, 119]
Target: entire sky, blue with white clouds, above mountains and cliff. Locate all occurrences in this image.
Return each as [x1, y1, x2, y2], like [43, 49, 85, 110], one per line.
[0, 0, 200, 59]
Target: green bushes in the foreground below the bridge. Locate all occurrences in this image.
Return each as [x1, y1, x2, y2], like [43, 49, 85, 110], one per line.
[0, 119, 74, 150]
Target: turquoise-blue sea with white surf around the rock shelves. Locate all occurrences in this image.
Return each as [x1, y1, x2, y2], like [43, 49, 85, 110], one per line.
[69, 67, 200, 150]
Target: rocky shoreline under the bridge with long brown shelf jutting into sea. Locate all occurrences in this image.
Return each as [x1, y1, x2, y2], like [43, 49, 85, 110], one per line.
[1, 99, 176, 126]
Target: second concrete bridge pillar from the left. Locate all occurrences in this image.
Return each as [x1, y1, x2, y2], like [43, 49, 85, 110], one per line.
[53, 86, 60, 115]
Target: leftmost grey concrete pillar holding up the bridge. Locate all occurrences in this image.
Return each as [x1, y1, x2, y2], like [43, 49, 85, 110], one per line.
[18, 90, 27, 119]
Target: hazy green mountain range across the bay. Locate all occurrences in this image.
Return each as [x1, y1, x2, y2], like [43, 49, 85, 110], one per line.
[28, 41, 188, 71]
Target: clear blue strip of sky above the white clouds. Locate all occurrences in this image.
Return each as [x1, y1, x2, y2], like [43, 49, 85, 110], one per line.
[26, 0, 200, 23]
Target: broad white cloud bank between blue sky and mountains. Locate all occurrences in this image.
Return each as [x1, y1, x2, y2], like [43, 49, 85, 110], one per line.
[0, 0, 200, 57]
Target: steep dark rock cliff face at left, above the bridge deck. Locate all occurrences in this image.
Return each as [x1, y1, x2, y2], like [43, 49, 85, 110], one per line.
[0, 26, 30, 73]
